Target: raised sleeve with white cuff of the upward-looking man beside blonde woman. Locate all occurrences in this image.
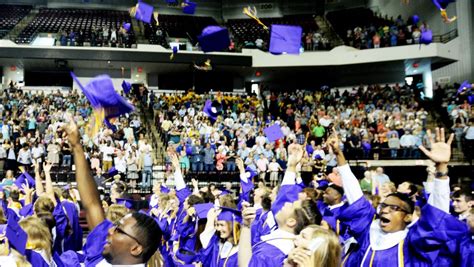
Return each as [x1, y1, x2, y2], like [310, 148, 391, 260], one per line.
[272, 171, 302, 215]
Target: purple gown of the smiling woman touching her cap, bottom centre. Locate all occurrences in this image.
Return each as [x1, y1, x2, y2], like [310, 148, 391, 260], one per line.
[200, 234, 239, 267]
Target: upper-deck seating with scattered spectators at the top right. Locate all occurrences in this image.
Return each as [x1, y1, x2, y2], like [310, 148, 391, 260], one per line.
[326, 8, 420, 49]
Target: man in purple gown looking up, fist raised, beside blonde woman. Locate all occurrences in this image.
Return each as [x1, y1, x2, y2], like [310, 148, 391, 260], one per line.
[239, 144, 321, 267]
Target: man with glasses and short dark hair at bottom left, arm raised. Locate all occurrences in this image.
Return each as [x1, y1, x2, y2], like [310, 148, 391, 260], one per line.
[65, 118, 162, 267]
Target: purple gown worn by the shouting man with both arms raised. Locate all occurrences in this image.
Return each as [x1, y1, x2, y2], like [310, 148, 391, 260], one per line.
[339, 197, 466, 267]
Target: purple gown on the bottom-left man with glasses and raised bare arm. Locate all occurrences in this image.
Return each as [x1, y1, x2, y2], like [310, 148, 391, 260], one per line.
[83, 220, 113, 267]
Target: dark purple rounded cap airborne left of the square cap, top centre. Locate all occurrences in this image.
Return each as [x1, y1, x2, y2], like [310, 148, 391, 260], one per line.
[198, 26, 230, 52]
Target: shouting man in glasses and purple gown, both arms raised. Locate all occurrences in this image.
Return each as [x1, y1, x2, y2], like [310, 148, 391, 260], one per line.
[328, 128, 467, 267]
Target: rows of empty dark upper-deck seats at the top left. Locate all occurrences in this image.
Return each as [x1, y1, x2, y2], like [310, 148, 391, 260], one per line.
[16, 8, 135, 44]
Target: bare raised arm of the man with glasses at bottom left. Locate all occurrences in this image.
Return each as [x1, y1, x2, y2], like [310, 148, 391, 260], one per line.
[64, 118, 105, 230]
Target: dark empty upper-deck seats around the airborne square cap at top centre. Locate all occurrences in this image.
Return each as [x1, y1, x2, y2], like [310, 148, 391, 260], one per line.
[227, 15, 318, 48]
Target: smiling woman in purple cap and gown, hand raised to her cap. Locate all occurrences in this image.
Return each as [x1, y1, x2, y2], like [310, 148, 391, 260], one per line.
[200, 207, 242, 267]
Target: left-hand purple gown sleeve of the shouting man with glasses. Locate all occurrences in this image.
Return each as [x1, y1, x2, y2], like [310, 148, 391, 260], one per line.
[337, 197, 375, 241]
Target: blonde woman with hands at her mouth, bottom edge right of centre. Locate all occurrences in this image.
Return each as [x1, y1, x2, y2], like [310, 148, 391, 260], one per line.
[284, 225, 342, 267]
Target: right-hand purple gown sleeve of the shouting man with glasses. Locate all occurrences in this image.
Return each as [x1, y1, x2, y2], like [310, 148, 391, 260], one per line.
[407, 204, 468, 264]
